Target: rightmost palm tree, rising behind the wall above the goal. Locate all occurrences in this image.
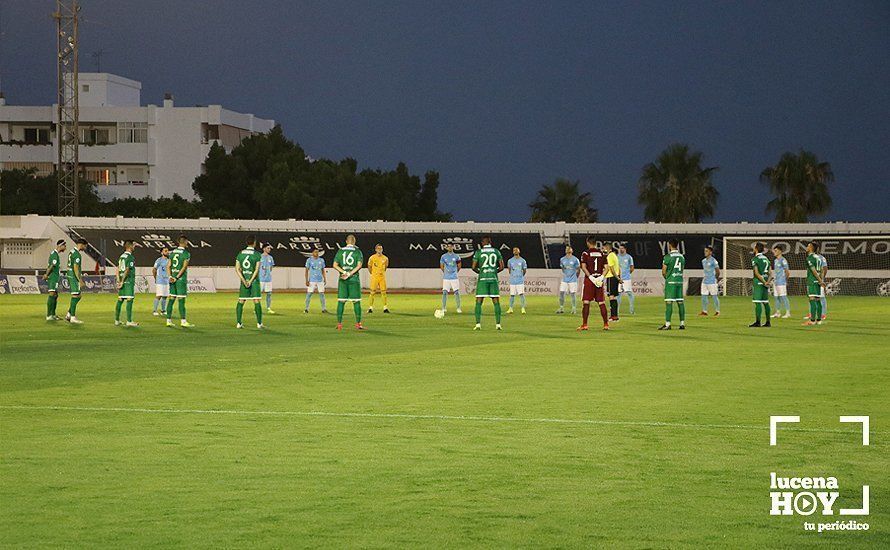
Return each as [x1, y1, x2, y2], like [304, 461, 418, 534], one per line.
[760, 149, 834, 223]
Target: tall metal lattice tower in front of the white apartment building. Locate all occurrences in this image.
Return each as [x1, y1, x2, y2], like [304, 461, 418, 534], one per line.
[53, 0, 80, 216]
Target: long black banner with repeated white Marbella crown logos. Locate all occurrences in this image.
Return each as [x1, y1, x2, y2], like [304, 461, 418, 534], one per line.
[71, 227, 546, 268]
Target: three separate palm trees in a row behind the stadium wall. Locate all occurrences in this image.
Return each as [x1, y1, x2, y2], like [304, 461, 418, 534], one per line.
[529, 147, 834, 223]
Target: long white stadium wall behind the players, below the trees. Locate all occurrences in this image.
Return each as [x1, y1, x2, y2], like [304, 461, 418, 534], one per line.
[0, 215, 890, 294]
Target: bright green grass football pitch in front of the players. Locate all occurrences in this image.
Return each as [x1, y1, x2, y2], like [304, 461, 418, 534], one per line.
[0, 294, 890, 548]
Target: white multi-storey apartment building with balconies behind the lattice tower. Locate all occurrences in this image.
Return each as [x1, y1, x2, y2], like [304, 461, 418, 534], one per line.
[0, 73, 275, 200]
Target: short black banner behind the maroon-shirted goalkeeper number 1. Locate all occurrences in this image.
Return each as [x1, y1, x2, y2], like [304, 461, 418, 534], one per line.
[560, 233, 723, 269]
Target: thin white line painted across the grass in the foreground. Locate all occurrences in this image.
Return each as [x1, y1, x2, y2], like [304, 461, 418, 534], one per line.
[0, 405, 864, 434]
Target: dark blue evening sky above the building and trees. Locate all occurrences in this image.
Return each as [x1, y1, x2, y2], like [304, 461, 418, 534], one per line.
[0, 0, 890, 221]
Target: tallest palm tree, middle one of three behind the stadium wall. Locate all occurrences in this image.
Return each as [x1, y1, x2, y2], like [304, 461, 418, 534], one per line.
[637, 143, 719, 223]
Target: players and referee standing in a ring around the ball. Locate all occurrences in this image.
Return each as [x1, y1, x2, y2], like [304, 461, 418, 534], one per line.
[43, 235, 828, 331]
